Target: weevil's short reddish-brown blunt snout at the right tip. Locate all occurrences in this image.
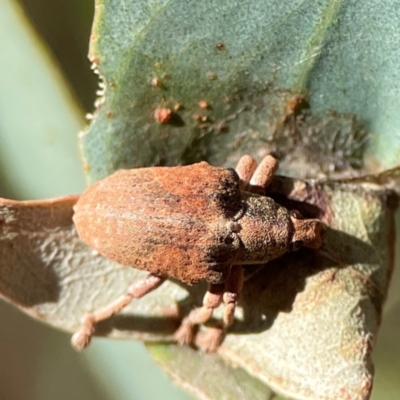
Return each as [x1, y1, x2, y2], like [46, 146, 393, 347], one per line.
[290, 215, 323, 250]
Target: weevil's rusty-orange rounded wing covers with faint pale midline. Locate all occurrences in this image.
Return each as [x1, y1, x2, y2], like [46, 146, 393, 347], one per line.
[74, 163, 243, 284]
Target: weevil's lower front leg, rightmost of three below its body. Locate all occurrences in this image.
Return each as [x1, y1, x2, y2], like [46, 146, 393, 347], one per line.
[200, 265, 244, 353]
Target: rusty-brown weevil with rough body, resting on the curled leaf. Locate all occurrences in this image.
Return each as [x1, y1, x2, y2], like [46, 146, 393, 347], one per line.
[72, 156, 322, 351]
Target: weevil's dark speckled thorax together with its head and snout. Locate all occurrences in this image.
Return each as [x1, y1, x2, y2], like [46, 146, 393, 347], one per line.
[229, 193, 322, 264]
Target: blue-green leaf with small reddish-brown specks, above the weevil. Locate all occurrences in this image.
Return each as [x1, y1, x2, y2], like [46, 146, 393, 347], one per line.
[82, 0, 400, 181]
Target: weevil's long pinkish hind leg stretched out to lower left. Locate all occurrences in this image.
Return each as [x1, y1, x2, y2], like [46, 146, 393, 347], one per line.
[71, 274, 166, 350]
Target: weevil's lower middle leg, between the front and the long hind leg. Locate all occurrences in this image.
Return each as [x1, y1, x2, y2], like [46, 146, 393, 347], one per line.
[174, 283, 225, 344]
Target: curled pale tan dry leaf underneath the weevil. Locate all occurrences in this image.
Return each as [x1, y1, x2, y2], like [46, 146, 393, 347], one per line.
[0, 174, 397, 400]
